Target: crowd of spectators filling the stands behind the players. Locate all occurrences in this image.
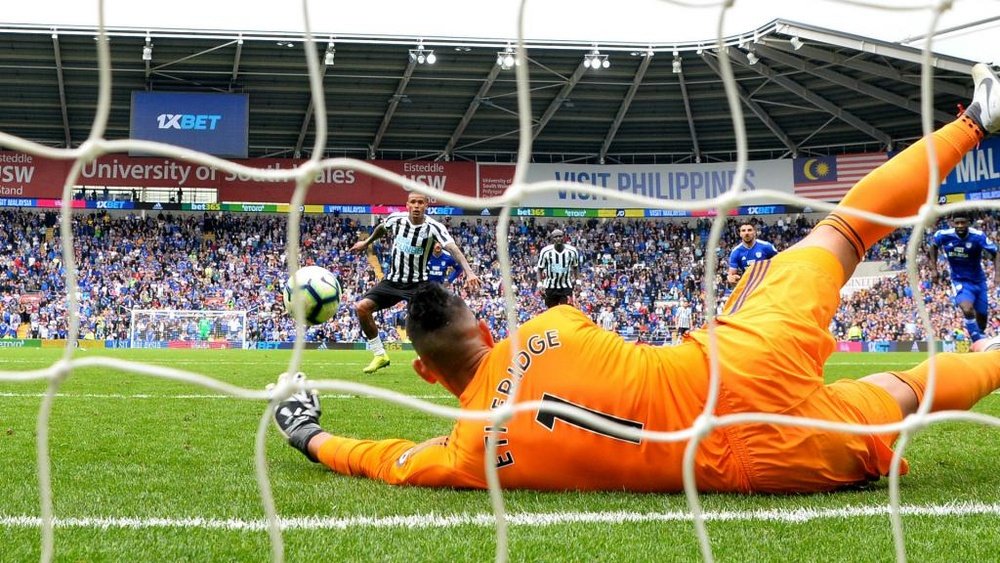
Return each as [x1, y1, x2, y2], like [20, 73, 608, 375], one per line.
[0, 210, 998, 342]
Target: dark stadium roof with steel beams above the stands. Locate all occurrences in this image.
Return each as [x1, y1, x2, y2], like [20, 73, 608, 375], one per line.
[0, 20, 974, 164]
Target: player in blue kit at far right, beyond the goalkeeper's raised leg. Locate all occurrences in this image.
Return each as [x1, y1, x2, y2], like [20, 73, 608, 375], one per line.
[928, 215, 1000, 342]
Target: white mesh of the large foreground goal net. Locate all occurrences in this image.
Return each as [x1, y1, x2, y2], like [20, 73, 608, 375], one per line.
[0, 1, 1000, 561]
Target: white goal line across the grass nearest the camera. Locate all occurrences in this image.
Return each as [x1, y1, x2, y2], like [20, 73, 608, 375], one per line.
[0, 502, 1000, 531]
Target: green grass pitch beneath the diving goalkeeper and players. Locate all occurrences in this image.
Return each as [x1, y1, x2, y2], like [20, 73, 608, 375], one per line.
[0, 349, 1000, 561]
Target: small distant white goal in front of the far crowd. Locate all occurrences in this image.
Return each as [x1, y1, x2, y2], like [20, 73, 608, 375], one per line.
[128, 309, 247, 349]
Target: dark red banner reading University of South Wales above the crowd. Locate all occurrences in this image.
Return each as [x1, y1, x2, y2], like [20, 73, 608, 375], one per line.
[0, 152, 476, 205]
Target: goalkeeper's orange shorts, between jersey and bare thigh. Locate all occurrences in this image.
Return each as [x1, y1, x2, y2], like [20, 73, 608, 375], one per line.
[694, 247, 906, 492]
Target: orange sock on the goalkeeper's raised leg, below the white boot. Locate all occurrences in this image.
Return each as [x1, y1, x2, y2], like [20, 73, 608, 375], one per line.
[817, 116, 983, 259]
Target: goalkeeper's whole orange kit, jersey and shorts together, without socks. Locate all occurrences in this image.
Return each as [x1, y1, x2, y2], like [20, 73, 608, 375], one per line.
[318, 248, 905, 492]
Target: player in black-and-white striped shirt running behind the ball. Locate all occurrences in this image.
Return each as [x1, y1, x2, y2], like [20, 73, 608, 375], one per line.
[351, 192, 479, 373]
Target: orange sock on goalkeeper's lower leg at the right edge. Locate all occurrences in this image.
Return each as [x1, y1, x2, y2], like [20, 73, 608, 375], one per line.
[890, 352, 1000, 411]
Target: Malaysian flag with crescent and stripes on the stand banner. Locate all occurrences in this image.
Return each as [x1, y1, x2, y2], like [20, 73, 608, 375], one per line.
[792, 152, 888, 201]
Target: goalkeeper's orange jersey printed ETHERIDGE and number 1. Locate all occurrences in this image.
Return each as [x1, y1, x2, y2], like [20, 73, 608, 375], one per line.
[319, 305, 725, 490]
